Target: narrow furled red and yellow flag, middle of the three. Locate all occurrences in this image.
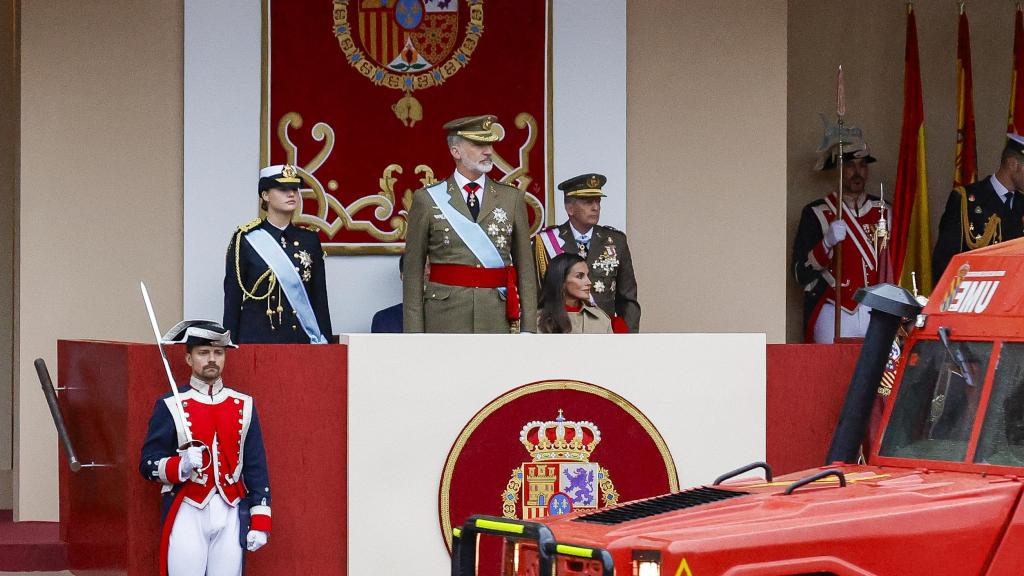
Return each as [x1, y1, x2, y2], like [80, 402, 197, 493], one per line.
[953, 4, 974, 188]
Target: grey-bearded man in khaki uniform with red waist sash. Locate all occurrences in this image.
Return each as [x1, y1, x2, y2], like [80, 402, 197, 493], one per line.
[402, 115, 537, 334]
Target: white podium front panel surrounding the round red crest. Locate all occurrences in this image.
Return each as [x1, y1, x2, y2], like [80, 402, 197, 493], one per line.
[348, 334, 765, 574]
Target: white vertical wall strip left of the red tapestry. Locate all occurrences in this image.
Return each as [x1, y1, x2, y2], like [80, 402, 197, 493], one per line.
[182, 0, 260, 322]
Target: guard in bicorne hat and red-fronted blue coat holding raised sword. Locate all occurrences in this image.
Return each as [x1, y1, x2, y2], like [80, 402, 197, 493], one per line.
[139, 320, 270, 576]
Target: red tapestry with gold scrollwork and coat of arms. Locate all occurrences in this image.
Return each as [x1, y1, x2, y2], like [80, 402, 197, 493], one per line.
[260, 0, 553, 254]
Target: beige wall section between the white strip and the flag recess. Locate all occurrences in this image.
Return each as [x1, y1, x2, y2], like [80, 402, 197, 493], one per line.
[627, 0, 786, 342]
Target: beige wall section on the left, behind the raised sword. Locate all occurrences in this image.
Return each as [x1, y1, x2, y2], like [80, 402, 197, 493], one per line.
[15, 0, 183, 521]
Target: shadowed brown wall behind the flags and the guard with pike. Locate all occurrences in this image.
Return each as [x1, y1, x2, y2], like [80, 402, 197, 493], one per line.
[786, 0, 1015, 341]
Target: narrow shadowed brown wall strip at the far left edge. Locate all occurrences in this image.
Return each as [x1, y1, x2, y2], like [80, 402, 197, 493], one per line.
[0, 0, 18, 509]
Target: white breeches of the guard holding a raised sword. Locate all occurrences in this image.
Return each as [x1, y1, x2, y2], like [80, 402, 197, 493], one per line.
[167, 495, 243, 576]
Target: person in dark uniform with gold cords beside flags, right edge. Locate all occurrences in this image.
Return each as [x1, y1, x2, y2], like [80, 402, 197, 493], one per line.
[932, 134, 1024, 283]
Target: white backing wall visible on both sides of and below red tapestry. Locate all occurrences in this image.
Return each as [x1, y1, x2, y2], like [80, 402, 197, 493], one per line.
[183, 0, 626, 333]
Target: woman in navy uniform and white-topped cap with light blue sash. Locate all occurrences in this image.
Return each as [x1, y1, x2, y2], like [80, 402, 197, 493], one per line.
[224, 164, 331, 344]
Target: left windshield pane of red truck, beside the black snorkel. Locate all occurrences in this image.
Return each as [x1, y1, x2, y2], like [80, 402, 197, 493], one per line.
[879, 340, 992, 462]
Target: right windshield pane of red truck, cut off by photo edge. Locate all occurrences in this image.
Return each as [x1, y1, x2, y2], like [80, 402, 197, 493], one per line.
[974, 342, 1024, 466]
